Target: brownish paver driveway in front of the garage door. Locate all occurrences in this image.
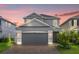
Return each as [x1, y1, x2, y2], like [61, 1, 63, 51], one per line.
[4, 45, 59, 54]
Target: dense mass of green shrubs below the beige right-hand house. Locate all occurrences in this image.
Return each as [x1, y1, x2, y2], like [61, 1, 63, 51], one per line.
[58, 30, 79, 48]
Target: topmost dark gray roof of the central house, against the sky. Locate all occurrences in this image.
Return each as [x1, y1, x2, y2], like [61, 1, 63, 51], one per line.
[24, 13, 59, 20]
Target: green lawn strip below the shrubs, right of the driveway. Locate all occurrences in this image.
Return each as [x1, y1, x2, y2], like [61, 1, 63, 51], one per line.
[57, 45, 79, 54]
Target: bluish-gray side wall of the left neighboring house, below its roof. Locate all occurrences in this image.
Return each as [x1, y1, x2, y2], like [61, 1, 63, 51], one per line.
[1, 20, 16, 38]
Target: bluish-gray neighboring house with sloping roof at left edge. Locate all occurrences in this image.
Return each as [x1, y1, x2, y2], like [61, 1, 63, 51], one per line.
[0, 16, 16, 38]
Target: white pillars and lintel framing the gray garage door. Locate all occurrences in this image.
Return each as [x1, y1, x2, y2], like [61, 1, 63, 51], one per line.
[16, 31, 53, 45]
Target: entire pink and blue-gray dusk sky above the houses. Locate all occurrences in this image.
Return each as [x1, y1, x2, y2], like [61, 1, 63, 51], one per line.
[0, 4, 79, 25]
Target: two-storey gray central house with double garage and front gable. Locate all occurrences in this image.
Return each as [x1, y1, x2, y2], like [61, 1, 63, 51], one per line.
[16, 13, 60, 45]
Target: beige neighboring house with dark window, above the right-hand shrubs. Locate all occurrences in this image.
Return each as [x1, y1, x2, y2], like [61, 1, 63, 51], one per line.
[60, 16, 79, 31]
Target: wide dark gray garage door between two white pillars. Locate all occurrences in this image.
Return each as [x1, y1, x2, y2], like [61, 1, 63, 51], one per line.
[22, 33, 48, 45]
